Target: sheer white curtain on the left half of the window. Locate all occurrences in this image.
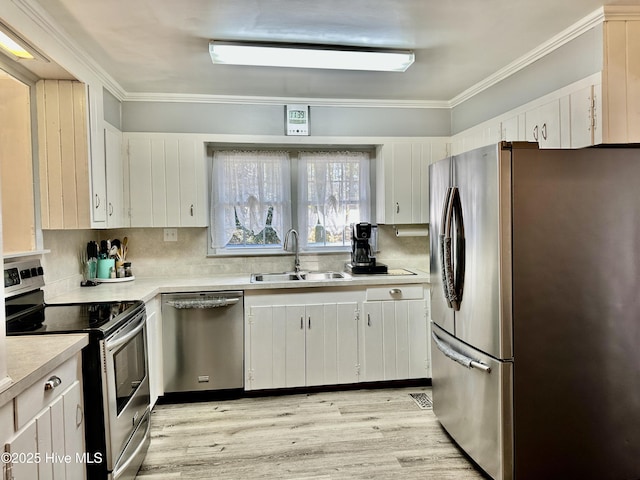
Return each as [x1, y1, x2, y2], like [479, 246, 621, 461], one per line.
[211, 151, 291, 248]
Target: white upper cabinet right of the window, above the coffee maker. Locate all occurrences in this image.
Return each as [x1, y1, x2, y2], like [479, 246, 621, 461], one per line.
[376, 138, 447, 225]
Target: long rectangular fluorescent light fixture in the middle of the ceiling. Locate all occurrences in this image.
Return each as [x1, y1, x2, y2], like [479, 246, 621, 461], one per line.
[209, 40, 415, 72]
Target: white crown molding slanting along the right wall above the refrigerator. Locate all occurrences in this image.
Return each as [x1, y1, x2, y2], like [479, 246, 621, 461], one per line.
[449, 7, 604, 108]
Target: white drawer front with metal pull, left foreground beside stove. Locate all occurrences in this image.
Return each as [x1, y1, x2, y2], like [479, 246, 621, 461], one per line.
[14, 353, 81, 431]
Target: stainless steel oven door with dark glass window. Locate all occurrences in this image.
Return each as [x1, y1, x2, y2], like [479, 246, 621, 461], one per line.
[102, 310, 150, 471]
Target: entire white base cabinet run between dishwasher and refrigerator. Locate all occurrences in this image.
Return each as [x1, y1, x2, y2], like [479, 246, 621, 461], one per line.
[244, 284, 431, 390]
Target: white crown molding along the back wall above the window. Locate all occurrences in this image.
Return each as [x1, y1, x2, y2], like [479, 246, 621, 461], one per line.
[124, 93, 450, 108]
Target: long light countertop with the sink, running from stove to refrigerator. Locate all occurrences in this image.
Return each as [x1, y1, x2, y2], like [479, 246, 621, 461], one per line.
[47, 269, 429, 304]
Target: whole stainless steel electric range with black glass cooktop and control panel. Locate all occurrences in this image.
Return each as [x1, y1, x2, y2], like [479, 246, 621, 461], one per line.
[4, 260, 150, 480]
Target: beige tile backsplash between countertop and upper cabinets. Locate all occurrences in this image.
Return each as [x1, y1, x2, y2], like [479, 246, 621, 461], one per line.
[43, 225, 429, 298]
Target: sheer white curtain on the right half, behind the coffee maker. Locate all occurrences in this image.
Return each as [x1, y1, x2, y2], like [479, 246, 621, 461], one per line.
[298, 152, 371, 246]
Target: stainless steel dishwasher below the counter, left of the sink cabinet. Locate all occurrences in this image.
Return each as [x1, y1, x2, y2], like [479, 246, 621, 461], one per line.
[162, 291, 244, 393]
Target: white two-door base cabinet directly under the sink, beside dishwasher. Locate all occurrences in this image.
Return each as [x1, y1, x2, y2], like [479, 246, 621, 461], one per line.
[245, 290, 360, 390]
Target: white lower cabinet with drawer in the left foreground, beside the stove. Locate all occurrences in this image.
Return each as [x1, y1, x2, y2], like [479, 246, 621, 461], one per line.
[3, 354, 86, 480]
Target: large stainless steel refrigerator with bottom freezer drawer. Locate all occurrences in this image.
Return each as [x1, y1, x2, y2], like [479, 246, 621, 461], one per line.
[430, 142, 640, 480]
